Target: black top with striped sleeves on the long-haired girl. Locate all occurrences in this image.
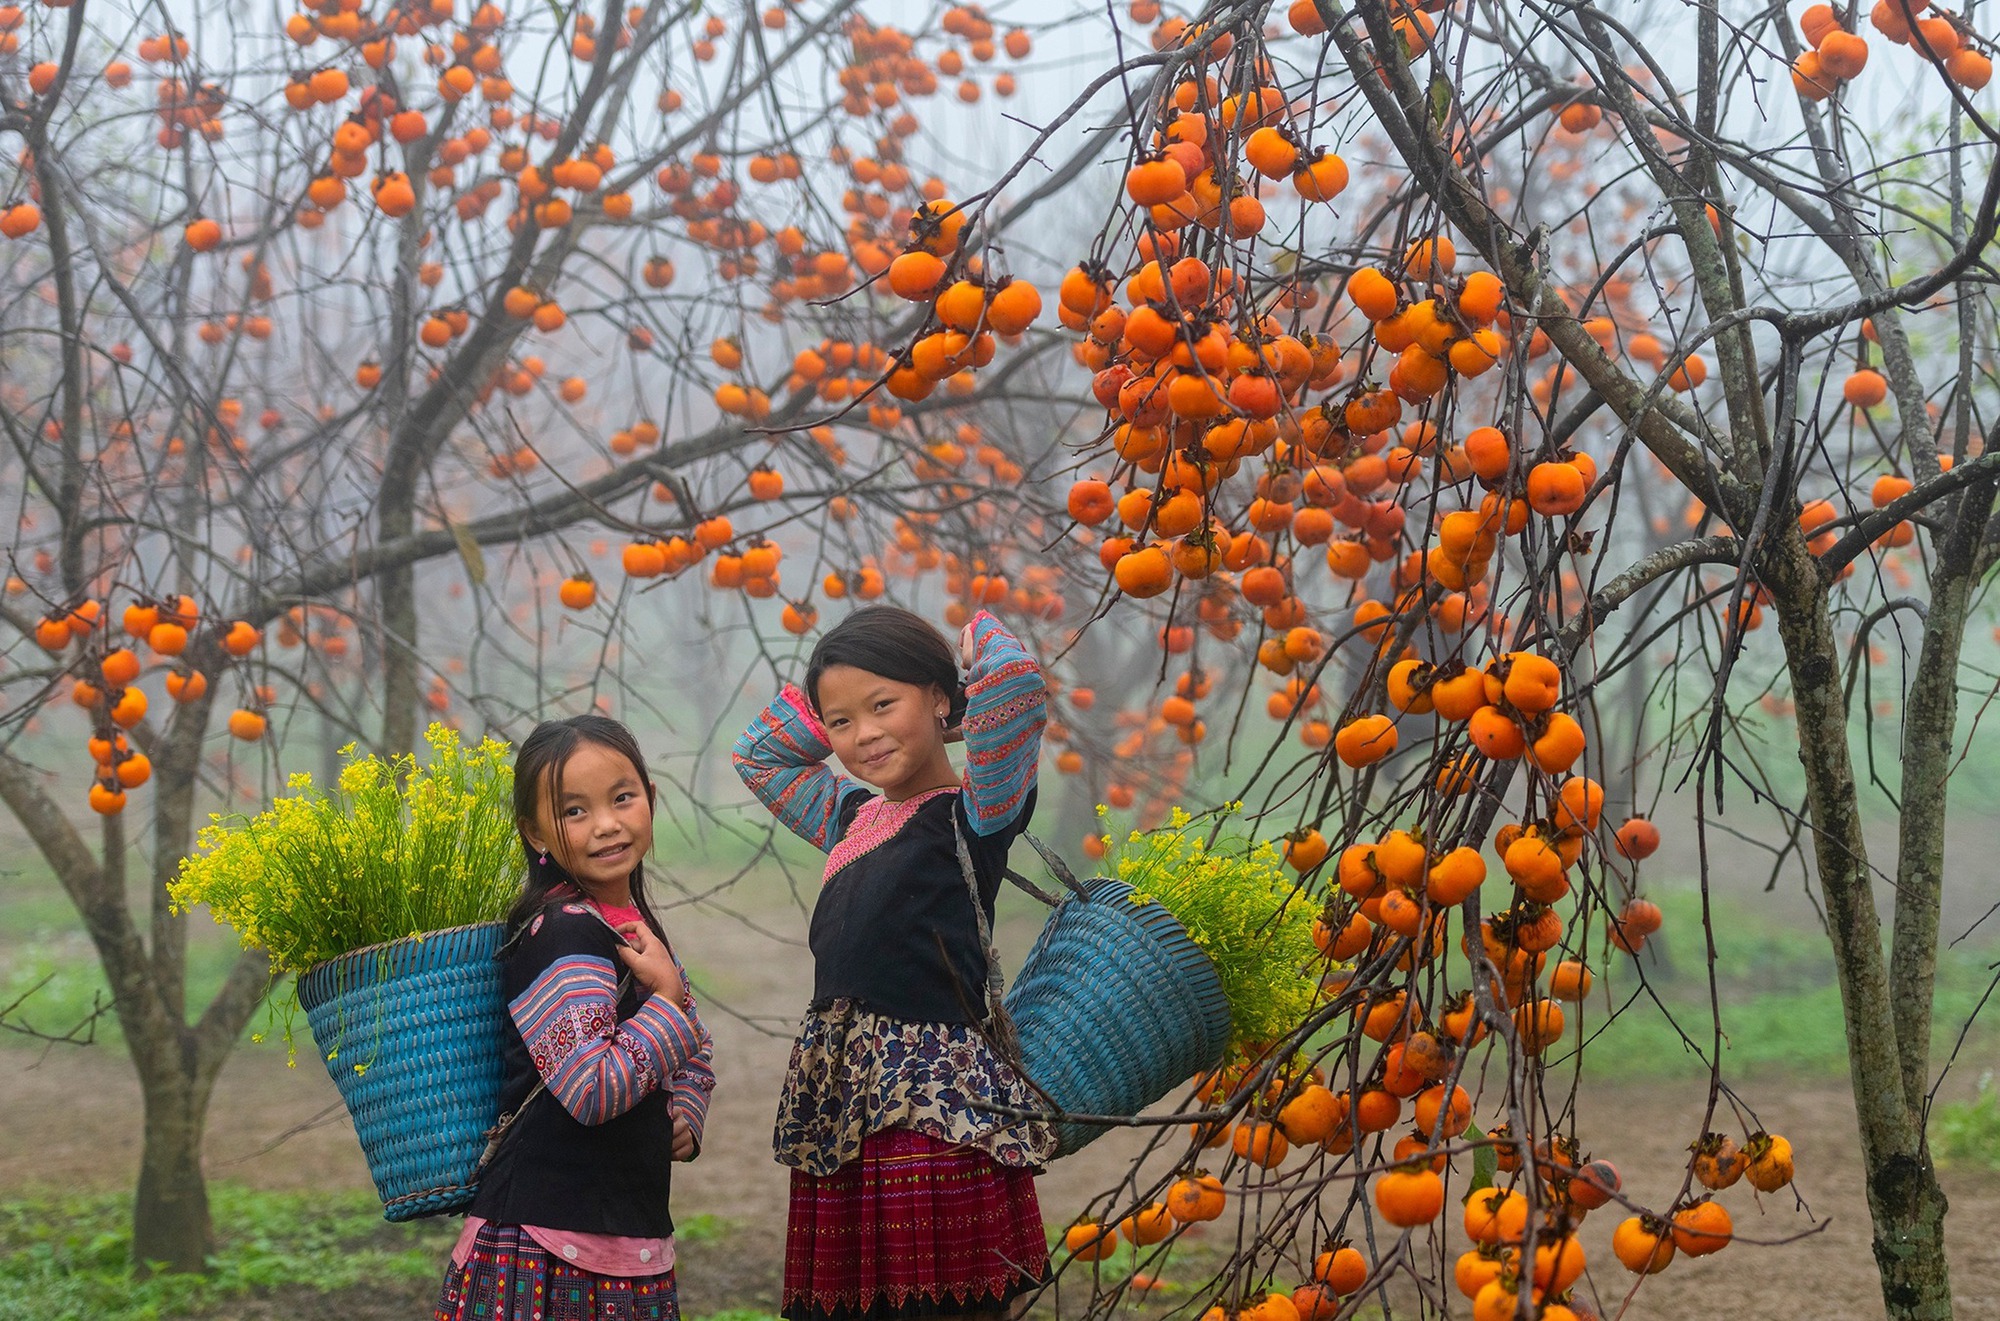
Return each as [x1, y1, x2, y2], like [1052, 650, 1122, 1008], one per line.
[470, 897, 714, 1239]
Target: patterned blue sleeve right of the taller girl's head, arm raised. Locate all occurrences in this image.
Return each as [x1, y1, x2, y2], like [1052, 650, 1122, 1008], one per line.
[960, 610, 1048, 835]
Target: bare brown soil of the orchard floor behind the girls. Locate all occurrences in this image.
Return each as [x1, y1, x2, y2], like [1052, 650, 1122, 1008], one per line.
[0, 868, 2000, 1321]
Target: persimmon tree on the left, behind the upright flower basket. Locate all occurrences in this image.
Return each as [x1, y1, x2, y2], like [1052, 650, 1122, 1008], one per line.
[0, 0, 1088, 1269]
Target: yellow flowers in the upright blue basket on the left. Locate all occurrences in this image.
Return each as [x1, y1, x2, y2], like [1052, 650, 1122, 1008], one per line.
[170, 725, 522, 973]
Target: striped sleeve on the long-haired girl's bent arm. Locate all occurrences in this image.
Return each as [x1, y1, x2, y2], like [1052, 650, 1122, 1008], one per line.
[508, 955, 700, 1123]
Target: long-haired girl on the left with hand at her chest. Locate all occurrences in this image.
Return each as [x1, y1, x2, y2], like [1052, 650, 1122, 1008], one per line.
[436, 715, 714, 1321]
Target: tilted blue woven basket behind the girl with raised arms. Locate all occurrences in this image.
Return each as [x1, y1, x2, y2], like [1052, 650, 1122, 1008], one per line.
[1006, 877, 1230, 1155]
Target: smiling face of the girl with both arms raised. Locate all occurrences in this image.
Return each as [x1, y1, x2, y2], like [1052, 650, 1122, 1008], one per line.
[818, 665, 958, 803]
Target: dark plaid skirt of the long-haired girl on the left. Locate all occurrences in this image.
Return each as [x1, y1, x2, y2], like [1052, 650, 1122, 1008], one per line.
[434, 1225, 680, 1321]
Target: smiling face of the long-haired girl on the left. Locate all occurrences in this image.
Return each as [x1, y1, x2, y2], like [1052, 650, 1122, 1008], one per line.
[522, 743, 652, 905]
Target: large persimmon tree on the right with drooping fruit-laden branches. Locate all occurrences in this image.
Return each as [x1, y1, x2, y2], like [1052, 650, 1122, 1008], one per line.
[856, 0, 2000, 1321]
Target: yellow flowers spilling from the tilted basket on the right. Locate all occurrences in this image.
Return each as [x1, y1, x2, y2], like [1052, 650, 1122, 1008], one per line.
[1098, 805, 1320, 1047]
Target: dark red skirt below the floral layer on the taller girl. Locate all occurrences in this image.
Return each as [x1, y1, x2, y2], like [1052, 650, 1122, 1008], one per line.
[782, 1129, 1048, 1321]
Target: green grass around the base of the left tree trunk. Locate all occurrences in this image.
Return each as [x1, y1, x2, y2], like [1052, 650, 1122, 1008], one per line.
[0, 1183, 744, 1321]
